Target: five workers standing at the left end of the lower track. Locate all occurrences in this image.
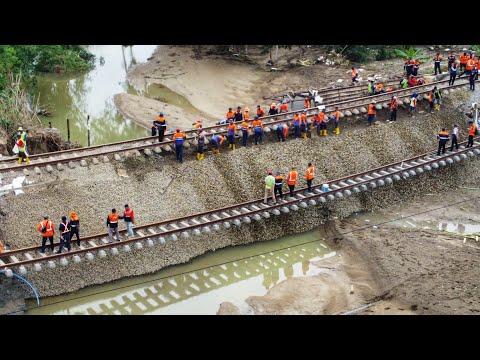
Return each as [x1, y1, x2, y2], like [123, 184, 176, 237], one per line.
[37, 204, 135, 254]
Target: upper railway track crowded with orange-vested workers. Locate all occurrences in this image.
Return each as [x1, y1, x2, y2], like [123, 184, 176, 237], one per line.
[0, 78, 468, 174]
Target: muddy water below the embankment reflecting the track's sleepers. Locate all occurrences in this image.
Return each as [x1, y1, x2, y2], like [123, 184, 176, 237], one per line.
[26, 230, 335, 315]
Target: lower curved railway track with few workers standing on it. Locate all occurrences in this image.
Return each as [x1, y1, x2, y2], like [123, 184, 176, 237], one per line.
[0, 137, 480, 276]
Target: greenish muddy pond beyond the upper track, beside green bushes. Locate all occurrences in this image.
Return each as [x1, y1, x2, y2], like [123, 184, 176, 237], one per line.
[35, 45, 198, 146]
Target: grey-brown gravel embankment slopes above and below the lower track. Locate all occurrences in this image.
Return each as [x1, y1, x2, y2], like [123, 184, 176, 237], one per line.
[1, 91, 479, 296]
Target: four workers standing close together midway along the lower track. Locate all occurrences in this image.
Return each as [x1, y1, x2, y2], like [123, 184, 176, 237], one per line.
[263, 163, 315, 205]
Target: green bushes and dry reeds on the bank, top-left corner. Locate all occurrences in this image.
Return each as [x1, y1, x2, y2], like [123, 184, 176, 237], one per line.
[0, 45, 95, 132]
